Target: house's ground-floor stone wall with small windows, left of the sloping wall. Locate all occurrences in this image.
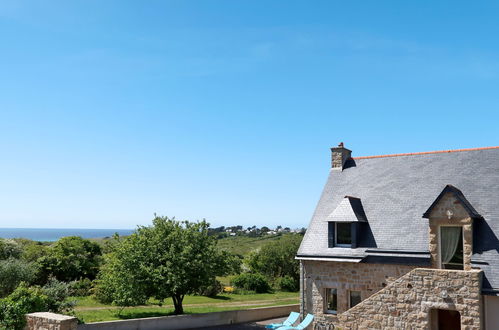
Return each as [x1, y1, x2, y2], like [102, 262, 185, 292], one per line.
[302, 260, 415, 322]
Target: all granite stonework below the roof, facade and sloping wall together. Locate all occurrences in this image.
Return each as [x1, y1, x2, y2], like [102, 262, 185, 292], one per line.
[302, 261, 483, 329]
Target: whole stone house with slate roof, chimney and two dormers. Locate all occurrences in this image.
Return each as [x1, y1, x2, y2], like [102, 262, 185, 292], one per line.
[296, 143, 499, 330]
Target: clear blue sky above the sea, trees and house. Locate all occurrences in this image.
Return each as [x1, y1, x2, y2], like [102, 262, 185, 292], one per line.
[0, 0, 499, 228]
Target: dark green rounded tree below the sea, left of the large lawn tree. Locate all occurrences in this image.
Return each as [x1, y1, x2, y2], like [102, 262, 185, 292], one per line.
[38, 236, 102, 282]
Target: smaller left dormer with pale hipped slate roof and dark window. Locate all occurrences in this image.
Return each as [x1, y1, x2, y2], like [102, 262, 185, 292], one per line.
[327, 196, 367, 248]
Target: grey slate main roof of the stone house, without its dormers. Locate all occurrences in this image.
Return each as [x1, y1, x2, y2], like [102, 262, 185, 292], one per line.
[297, 147, 499, 291]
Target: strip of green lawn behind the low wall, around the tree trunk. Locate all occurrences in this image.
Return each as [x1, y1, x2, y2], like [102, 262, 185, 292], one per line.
[73, 292, 299, 323]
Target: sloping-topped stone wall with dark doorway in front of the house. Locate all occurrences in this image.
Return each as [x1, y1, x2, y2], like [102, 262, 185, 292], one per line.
[336, 268, 483, 330]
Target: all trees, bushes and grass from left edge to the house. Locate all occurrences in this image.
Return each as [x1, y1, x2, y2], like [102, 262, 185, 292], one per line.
[0, 217, 303, 329]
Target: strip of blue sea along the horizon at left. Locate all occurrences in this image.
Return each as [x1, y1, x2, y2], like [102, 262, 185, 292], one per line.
[0, 228, 134, 242]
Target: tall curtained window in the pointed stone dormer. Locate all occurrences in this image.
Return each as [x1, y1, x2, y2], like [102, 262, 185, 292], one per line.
[440, 226, 464, 269]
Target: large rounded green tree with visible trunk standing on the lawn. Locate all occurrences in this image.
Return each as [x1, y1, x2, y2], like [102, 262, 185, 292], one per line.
[98, 217, 240, 314]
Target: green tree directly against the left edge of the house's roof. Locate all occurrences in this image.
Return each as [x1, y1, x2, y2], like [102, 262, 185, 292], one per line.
[247, 234, 302, 281]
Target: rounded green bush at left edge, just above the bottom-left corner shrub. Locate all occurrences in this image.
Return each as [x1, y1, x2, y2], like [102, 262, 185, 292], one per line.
[0, 258, 38, 297]
